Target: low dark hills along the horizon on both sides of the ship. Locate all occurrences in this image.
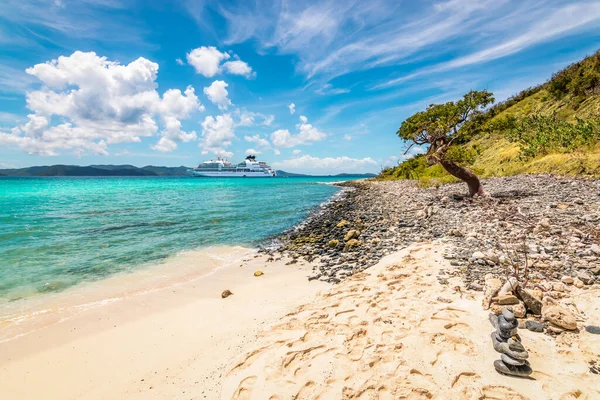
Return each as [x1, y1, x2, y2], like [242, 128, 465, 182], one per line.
[0, 164, 376, 178]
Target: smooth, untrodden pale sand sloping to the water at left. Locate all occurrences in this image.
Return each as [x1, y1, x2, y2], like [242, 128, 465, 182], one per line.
[0, 248, 327, 400]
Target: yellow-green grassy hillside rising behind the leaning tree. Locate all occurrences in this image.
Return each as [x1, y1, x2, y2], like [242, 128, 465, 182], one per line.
[379, 51, 600, 185]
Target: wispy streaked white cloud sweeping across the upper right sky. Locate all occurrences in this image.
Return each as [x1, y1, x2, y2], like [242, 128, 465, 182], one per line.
[209, 0, 600, 87]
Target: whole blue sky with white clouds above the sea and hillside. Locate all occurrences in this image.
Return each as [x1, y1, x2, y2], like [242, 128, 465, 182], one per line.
[0, 0, 600, 173]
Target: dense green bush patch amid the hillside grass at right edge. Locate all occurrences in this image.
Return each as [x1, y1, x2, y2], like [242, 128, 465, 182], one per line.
[497, 115, 600, 158]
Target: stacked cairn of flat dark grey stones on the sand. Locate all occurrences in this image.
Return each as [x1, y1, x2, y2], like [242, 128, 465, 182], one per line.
[490, 307, 532, 377]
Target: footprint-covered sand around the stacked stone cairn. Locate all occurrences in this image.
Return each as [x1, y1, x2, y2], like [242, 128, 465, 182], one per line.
[222, 244, 600, 400]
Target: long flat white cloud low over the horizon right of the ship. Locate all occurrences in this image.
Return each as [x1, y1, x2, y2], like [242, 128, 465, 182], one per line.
[273, 154, 377, 174]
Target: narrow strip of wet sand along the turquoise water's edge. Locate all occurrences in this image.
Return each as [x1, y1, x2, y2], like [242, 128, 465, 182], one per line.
[0, 181, 346, 343]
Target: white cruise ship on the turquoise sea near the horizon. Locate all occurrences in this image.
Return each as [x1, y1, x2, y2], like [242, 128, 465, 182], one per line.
[190, 156, 277, 178]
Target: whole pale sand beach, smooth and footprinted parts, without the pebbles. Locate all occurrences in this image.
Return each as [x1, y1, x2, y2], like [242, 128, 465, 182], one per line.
[0, 239, 600, 400]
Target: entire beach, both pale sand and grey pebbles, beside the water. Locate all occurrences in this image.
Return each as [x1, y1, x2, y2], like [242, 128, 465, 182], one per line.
[0, 176, 600, 400]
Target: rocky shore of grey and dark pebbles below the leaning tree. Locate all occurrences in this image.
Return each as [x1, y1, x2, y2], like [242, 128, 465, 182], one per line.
[262, 175, 600, 290]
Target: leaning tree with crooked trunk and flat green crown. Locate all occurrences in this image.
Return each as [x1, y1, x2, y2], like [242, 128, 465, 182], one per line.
[397, 90, 494, 196]
